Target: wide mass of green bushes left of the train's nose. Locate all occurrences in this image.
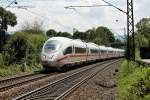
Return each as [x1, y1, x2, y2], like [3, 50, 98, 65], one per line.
[3, 33, 47, 65]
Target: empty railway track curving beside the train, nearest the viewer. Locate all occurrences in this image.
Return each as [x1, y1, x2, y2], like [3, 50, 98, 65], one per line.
[14, 60, 119, 100]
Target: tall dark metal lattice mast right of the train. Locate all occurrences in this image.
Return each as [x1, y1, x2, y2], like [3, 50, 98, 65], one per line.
[127, 0, 135, 60]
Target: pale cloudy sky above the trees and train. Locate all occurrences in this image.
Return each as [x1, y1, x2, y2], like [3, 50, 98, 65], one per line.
[0, 0, 150, 34]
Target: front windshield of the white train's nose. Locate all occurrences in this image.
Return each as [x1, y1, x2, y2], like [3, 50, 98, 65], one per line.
[44, 40, 59, 52]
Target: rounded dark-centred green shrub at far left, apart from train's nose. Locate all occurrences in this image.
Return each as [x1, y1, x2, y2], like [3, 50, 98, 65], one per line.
[3, 33, 34, 65]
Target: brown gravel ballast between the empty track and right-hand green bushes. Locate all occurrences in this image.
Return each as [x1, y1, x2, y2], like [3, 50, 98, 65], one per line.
[66, 60, 119, 100]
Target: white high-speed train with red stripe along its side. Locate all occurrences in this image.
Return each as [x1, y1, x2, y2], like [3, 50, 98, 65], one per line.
[41, 37, 124, 68]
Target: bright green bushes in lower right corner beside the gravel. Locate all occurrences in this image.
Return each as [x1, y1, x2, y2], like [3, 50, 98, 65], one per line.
[118, 61, 150, 100]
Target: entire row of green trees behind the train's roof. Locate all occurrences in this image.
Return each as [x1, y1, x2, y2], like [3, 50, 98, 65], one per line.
[46, 26, 115, 46]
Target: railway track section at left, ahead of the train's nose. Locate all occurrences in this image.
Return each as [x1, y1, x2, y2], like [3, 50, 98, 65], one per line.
[0, 74, 56, 92]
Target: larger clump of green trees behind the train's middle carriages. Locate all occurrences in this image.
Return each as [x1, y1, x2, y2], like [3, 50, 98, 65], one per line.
[73, 26, 115, 46]
